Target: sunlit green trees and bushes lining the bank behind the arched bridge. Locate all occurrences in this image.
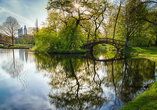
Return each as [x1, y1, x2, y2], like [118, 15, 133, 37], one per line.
[35, 0, 157, 51]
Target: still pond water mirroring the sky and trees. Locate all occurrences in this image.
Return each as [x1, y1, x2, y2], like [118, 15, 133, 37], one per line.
[0, 49, 157, 110]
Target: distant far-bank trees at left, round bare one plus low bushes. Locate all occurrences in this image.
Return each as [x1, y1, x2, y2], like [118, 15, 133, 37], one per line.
[0, 16, 36, 45]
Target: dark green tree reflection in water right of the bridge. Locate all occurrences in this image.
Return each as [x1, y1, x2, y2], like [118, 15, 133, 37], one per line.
[103, 59, 155, 102]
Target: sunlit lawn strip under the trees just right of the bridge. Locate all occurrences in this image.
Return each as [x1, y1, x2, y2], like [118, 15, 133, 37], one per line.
[122, 47, 157, 61]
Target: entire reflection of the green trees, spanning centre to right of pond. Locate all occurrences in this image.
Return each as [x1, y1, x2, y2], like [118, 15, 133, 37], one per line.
[36, 54, 155, 109]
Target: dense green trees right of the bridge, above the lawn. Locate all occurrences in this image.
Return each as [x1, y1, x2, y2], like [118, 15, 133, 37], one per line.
[106, 0, 157, 46]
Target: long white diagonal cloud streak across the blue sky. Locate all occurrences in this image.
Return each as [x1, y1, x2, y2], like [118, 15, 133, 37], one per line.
[0, 7, 35, 26]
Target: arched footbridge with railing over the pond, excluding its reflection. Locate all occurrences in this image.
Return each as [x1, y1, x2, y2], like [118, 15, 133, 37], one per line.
[84, 38, 127, 51]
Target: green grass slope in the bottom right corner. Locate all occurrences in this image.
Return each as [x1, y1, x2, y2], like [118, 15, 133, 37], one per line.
[121, 82, 157, 110]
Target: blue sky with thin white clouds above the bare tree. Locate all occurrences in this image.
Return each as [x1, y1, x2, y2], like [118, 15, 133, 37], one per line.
[0, 0, 48, 27]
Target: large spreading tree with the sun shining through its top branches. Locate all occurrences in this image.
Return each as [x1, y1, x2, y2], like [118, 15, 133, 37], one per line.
[46, 0, 108, 50]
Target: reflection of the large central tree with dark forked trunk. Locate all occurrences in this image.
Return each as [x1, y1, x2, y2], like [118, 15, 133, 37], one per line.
[34, 56, 107, 109]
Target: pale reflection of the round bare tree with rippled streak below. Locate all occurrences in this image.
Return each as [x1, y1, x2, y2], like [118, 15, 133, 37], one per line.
[2, 49, 28, 90]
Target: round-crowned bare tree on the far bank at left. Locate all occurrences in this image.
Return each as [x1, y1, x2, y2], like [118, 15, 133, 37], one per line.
[1, 16, 20, 45]
